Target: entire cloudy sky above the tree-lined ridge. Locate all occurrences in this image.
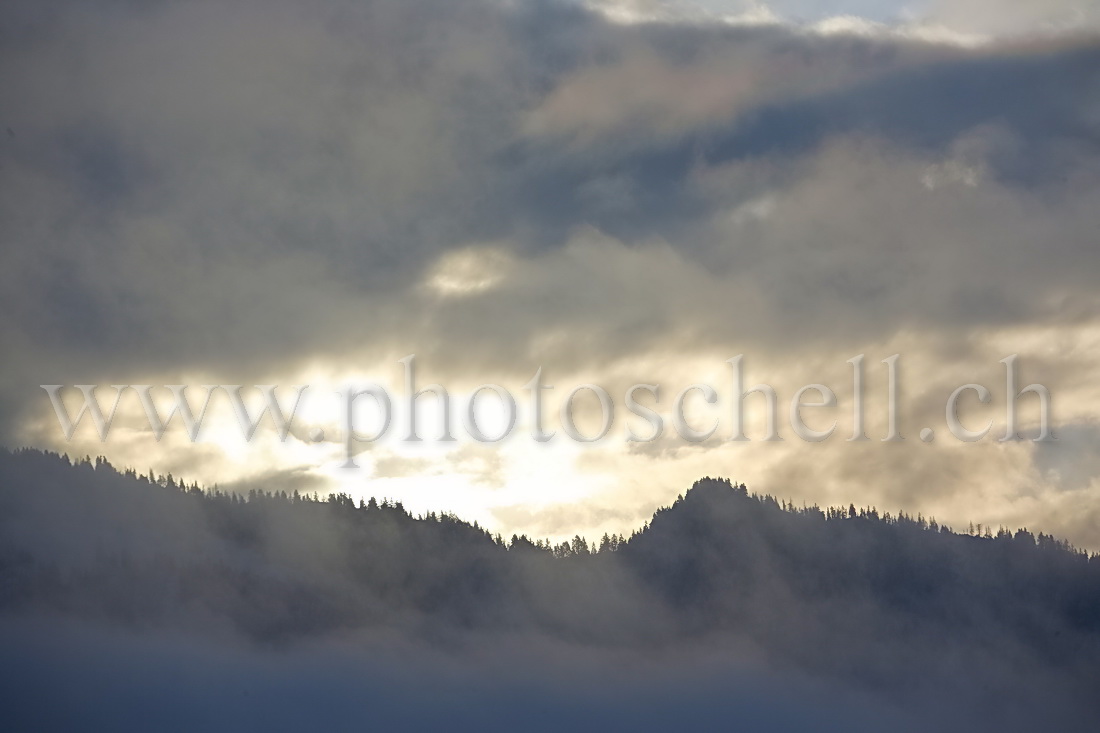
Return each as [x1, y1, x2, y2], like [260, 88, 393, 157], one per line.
[0, 0, 1100, 549]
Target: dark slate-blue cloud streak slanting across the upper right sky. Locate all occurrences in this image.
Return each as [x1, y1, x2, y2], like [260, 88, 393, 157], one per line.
[516, 36, 1100, 208]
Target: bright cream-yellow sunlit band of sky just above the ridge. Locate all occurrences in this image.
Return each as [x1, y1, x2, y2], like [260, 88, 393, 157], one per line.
[21, 329, 1086, 544]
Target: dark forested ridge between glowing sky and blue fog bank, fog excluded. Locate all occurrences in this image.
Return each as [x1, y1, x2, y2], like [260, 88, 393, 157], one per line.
[0, 450, 1100, 730]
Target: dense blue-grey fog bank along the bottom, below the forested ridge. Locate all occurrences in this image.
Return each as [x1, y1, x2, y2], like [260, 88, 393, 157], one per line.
[0, 623, 932, 731]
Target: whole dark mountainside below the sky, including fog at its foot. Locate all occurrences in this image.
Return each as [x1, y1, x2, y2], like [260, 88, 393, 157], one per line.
[0, 450, 1100, 731]
